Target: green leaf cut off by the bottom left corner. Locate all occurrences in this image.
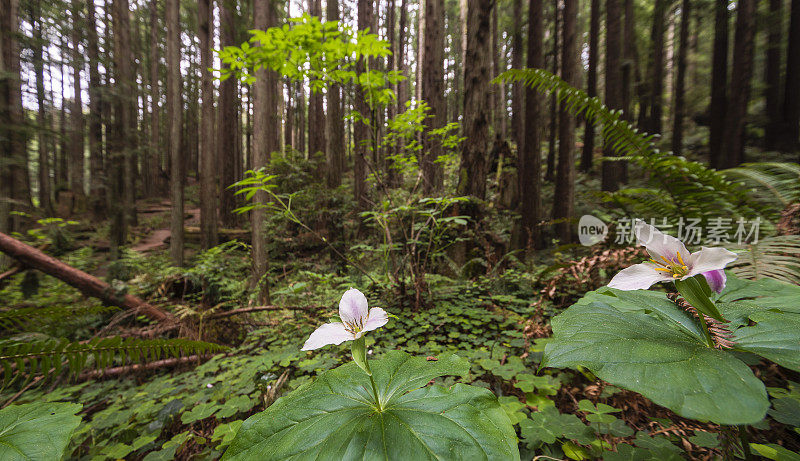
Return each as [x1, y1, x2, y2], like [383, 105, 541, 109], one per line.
[0, 402, 82, 461]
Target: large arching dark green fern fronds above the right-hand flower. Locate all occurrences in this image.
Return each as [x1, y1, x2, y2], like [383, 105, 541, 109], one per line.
[495, 69, 760, 223]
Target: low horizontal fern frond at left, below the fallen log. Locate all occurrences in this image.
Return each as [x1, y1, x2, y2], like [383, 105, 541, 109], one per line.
[0, 337, 227, 387]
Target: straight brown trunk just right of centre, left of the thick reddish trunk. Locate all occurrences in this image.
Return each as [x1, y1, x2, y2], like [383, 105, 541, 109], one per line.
[420, 0, 447, 195]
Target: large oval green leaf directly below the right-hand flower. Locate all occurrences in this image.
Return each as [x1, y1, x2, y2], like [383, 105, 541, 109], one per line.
[542, 302, 769, 424]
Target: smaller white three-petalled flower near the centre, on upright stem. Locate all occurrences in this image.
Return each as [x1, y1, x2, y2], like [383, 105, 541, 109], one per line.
[303, 288, 389, 351]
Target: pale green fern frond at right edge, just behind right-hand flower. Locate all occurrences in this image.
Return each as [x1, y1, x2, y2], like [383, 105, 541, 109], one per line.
[731, 235, 800, 284]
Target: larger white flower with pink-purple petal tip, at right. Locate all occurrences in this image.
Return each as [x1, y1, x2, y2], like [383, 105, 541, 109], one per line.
[608, 219, 738, 293]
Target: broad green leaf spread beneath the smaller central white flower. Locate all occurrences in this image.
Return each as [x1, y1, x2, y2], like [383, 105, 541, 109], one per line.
[223, 351, 519, 461]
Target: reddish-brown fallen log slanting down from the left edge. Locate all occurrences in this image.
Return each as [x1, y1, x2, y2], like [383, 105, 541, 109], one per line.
[0, 232, 174, 322]
